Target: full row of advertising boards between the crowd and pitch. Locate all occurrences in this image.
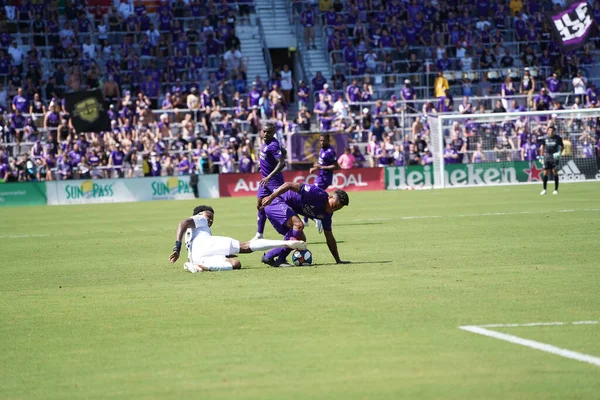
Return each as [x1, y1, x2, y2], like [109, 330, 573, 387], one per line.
[0, 162, 600, 207]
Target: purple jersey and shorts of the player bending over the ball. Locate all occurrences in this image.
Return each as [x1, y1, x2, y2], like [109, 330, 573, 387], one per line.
[265, 183, 333, 235]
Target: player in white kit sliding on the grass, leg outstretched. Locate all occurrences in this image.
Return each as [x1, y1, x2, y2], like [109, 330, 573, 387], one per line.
[169, 206, 306, 273]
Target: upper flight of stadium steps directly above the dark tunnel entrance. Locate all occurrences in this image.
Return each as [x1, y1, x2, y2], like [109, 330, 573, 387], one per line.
[254, 0, 297, 49]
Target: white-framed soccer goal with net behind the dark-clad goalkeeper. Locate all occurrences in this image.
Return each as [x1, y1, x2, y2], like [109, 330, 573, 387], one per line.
[427, 108, 600, 188]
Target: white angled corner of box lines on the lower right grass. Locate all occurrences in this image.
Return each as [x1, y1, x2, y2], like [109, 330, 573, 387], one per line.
[458, 321, 600, 367]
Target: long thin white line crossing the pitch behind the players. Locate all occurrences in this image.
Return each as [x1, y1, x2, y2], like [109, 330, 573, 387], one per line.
[0, 208, 600, 239]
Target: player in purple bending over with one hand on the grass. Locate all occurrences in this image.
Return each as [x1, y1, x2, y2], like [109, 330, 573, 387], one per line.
[262, 182, 350, 267]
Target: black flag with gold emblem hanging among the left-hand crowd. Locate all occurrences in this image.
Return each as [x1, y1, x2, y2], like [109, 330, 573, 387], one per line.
[65, 89, 110, 132]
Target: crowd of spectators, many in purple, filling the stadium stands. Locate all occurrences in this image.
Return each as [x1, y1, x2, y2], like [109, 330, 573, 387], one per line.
[0, 0, 600, 181]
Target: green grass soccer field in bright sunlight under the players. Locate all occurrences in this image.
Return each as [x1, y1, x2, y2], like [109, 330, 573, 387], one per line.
[0, 183, 600, 400]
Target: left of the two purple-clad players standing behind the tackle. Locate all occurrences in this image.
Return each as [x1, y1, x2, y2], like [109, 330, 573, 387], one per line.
[252, 122, 286, 240]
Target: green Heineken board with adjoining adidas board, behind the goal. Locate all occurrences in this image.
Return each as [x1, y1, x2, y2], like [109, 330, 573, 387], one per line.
[385, 158, 600, 190]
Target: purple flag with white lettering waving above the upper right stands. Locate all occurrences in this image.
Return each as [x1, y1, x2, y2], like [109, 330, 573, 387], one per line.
[548, 0, 596, 51]
